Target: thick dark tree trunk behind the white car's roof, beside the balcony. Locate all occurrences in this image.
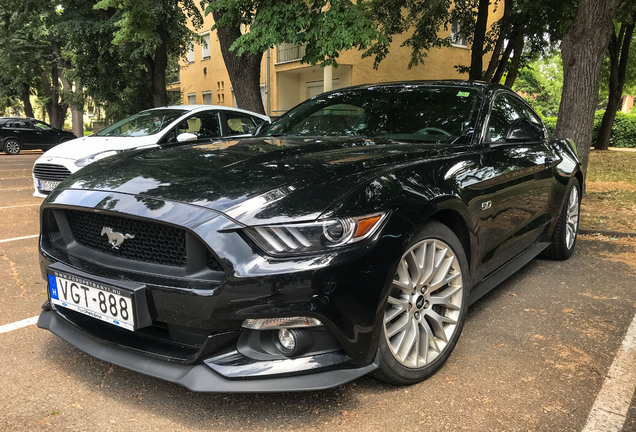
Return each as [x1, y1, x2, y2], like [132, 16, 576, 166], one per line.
[213, 12, 265, 114]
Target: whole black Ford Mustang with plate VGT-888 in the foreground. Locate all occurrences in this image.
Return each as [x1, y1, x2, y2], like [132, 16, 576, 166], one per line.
[38, 81, 583, 392]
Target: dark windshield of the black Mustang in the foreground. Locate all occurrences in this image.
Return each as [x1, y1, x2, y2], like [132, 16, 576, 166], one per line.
[263, 85, 482, 142]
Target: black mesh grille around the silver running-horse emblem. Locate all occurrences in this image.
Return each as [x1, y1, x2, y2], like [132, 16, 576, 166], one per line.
[66, 211, 186, 267]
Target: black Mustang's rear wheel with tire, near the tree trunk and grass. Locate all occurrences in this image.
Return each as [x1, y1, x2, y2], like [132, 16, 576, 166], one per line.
[542, 178, 581, 260]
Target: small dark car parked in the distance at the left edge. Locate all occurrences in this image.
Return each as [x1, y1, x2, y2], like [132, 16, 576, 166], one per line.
[0, 117, 77, 155]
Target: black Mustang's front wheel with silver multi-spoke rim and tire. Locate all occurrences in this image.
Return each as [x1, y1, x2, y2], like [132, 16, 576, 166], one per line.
[376, 221, 469, 385]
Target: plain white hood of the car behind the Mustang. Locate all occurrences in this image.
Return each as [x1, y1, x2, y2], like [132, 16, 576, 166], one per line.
[38, 135, 158, 161]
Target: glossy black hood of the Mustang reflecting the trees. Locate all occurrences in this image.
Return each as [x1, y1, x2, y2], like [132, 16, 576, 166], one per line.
[60, 138, 448, 225]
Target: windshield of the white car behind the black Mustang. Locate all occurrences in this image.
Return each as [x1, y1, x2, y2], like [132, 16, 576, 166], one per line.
[95, 109, 186, 137]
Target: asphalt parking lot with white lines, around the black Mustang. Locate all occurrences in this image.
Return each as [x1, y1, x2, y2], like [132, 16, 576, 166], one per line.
[0, 151, 636, 432]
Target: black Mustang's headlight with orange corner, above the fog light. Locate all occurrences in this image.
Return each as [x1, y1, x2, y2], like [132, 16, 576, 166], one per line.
[244, 212, 387, 255]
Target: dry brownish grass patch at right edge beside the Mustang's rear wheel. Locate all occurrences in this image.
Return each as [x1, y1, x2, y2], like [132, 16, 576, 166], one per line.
[581, 151, 636, 235]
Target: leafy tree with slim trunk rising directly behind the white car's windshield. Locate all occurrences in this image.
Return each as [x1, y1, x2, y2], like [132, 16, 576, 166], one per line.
[95, 0, 203, 106]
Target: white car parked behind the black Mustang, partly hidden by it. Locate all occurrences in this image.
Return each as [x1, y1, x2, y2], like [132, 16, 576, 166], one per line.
[33, 105, 270, 198]
